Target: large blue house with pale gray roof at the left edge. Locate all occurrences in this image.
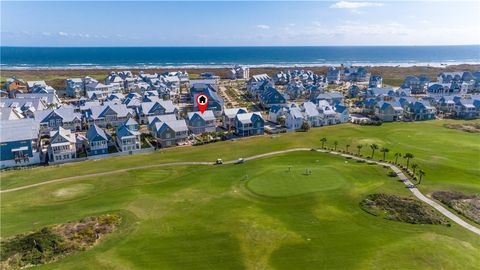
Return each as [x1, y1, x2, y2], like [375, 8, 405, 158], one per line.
[0, 119, 40, 168]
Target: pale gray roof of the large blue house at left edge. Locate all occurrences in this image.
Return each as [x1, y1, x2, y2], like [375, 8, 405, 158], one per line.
[0, 118, 39, 143]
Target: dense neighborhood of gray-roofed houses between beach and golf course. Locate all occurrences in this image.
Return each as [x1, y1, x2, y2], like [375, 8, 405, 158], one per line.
[0, 65, 480, 168]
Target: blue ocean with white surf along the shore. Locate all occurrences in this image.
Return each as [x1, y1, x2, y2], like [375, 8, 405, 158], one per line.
[0, 45, 480, 69]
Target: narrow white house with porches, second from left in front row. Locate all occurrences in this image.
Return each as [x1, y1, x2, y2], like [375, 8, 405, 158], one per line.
[48, 127, 77, 164]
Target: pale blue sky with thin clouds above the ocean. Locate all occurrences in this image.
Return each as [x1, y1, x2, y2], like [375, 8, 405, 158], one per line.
[0, 1, 480, 46]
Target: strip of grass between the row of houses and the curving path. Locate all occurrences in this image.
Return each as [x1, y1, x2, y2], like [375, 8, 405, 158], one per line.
[0, 120, 480, 193]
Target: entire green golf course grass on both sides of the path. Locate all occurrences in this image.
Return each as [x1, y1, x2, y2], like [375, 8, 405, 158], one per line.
[1, 121, 480, 269]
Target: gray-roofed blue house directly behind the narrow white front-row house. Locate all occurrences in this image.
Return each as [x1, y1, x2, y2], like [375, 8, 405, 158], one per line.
[34, 108, 82, 134]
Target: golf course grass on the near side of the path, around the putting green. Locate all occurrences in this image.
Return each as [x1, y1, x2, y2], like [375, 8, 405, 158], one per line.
[1, 151, 480, 269]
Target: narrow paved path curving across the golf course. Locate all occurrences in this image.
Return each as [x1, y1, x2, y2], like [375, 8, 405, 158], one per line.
[0, 148, 480, 235]
